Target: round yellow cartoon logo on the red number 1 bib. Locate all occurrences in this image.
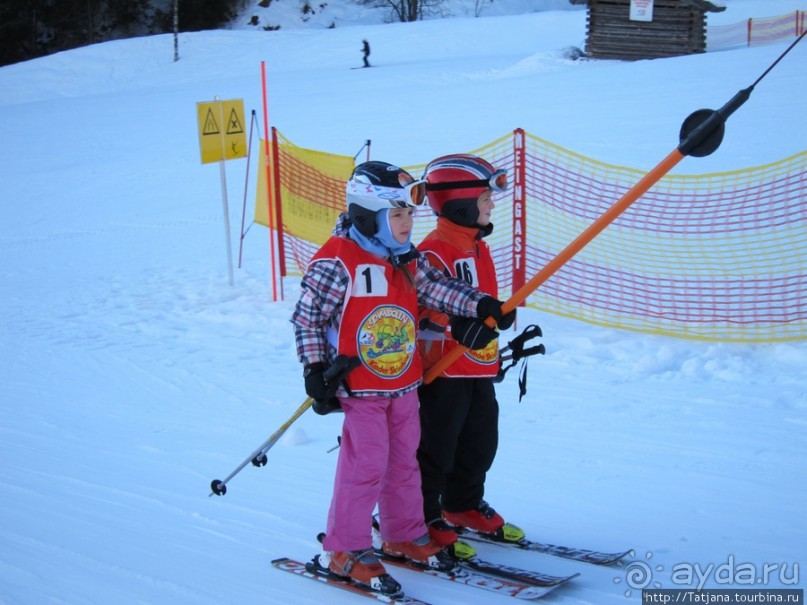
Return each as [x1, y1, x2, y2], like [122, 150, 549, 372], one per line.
[358, 305, 415, 378]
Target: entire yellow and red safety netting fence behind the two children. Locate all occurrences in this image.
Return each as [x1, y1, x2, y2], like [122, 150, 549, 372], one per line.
[256, 130, 807, 342]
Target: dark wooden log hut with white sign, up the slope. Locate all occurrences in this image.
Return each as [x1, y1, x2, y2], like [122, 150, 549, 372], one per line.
[570, 0, 726, 61]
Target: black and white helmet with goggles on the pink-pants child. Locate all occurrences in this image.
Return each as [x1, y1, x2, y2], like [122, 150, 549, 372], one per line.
[345, 161, 426, 237]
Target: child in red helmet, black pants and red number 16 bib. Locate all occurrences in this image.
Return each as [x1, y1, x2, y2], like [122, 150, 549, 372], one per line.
[418, 154, 524, 556]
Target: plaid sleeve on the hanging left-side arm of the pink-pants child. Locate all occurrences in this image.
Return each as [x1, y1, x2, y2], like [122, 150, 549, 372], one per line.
[291, 260, 350, 365]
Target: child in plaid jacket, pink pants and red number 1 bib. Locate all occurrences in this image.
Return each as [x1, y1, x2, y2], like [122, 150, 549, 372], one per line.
[291, 162, 502, 595]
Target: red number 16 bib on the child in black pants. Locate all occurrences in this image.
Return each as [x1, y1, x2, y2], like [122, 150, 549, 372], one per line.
[418, 224, 499, 378]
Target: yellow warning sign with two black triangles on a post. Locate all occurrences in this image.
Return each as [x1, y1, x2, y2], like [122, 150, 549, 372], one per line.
[196, 99, 247, 164]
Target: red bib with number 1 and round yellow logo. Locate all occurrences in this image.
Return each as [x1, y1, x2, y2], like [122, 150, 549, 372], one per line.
[311, 237, 423, 394]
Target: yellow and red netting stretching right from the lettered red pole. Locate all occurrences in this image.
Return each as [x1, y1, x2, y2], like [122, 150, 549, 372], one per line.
[526, 135, 807, 341]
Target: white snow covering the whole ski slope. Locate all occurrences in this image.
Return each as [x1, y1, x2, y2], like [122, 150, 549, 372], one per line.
[0, 0, 807, 605]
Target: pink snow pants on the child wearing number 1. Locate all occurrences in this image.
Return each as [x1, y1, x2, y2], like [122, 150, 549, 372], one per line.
[322, 390, 427, 551]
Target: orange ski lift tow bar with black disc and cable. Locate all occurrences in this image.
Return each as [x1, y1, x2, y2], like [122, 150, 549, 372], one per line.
[423, 32, 807, 384]
